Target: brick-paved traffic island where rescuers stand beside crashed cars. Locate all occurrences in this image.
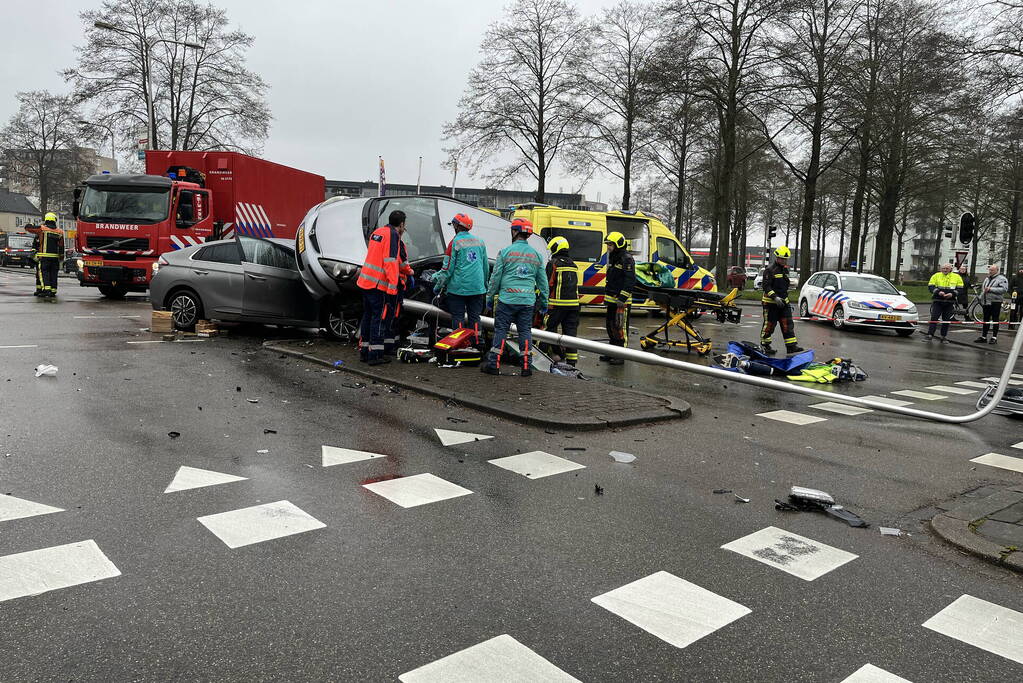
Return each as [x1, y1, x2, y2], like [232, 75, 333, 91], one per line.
[263, 339, 692, 430]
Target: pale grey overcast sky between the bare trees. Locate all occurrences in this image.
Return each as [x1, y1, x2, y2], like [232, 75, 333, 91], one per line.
[0, 0, 621, 201]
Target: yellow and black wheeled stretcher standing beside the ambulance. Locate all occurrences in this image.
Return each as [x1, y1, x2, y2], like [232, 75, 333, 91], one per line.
[636, 281, 742, 356]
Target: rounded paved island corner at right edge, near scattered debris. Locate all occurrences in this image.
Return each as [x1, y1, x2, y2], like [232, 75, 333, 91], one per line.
[931, 486, 1023, 572]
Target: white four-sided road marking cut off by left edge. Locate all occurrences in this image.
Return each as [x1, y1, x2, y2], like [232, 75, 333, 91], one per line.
[0, 540, 121, 602]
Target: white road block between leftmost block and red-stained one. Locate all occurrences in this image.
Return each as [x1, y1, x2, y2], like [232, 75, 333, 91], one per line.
[198, 500, 326, 548]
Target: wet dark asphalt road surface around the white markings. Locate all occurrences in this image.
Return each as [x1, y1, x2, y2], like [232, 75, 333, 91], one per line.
[0, 269, 1023, 682]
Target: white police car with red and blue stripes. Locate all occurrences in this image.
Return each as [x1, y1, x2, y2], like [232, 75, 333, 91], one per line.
[799, 270, 920, 336]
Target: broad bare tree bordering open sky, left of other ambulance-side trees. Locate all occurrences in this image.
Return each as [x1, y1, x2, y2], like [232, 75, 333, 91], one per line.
[444, 0, 587, 201]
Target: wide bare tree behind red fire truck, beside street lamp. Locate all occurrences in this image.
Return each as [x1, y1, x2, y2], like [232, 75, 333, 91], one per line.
[64, 0, 271, 152]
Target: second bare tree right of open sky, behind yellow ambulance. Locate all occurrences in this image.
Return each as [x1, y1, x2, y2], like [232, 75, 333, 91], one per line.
[573, 0, 659, 210]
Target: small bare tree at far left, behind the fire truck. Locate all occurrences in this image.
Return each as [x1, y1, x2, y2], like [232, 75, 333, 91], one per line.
[0, 90, 83, 212]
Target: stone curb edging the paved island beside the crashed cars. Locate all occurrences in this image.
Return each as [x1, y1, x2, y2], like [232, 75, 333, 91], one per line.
[263, 339, 693, 431]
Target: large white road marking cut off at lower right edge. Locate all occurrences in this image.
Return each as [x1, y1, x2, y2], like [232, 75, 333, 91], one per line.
[923, 595, 1023, 664]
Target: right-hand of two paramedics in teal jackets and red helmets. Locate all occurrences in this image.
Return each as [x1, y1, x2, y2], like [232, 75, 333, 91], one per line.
[480, 218, 549, 377]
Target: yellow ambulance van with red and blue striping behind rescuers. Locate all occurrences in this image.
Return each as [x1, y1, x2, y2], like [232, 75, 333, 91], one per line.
[501, 203, 717, 308]
